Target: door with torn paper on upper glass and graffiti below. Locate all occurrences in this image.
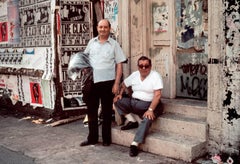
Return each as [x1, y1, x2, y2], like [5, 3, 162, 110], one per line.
[175, 0, 208, 100]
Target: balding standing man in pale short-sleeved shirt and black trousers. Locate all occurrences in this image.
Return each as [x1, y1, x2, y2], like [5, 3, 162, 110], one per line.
[80, 19, 126, 146]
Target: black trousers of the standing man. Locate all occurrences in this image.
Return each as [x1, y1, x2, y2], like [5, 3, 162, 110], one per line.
[87, 80, 114, 143]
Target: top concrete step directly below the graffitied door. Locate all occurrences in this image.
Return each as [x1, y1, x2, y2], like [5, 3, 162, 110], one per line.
[161, 98, 207, 119]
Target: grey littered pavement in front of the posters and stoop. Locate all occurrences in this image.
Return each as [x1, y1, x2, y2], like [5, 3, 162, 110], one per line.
[0, 109, 210, 164]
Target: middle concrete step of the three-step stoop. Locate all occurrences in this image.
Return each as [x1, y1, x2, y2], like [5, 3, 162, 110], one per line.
[151, 113, 207, 141]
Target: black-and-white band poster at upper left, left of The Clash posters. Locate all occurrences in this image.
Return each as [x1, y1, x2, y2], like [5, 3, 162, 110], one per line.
[19, 0, 52, 47]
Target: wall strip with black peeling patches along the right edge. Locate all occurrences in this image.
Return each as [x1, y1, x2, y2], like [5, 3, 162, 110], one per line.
[222, 0, 240, 153]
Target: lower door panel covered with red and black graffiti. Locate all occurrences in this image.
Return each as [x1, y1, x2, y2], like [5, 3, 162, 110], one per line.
[177, 53, 208, 100]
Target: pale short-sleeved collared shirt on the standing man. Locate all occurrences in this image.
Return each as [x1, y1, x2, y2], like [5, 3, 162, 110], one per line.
[84, 37, 126, 83]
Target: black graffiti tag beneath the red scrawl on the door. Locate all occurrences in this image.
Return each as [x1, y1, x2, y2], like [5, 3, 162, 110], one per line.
[180, 76, 207, 99]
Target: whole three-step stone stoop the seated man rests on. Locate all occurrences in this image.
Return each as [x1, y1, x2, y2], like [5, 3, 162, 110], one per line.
[112, 99, 207, 162]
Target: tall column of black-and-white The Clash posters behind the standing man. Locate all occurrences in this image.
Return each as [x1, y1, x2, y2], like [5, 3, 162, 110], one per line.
[60, 0, 92, 110]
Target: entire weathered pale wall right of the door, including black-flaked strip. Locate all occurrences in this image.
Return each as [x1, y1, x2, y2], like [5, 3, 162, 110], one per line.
[207, 0, 240, 153]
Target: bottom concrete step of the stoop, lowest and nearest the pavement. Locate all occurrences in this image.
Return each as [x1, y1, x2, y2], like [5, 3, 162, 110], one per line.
[112, 126, 206, 162]
